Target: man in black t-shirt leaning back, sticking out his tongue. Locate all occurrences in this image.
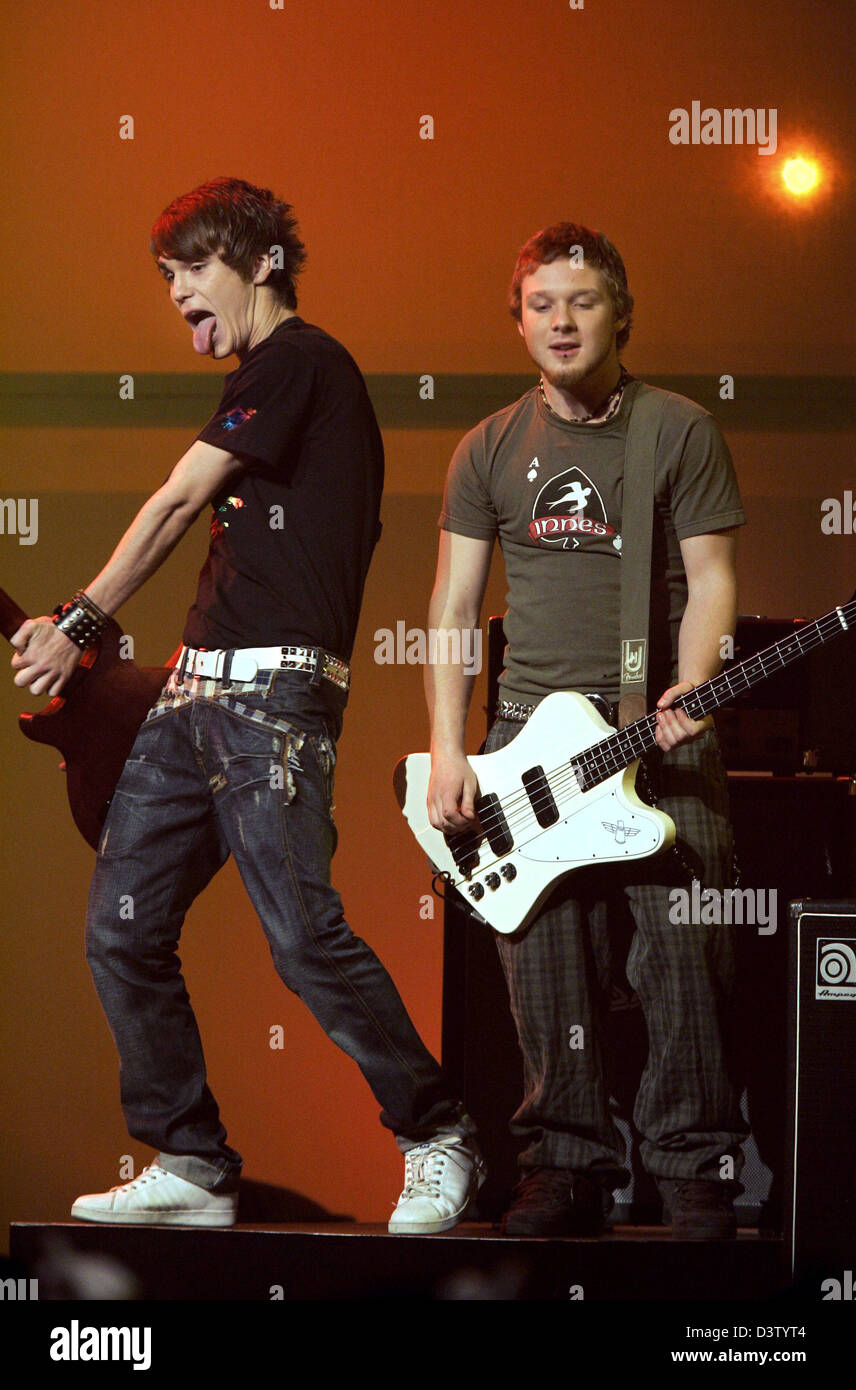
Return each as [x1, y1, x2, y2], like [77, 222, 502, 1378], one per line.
[13, 179, 482, 1233]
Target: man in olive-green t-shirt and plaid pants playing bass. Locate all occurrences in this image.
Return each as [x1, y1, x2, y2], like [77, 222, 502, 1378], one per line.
[428, 222, 746, 1238]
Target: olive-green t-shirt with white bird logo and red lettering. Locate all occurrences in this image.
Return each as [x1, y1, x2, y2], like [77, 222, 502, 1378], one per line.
[439, 379, 746, 703]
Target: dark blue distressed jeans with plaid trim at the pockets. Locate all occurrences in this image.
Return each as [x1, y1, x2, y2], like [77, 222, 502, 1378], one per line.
[86, 671, 472, 1191]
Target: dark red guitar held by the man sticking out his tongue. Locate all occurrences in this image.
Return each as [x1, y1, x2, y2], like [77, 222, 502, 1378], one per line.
[0, 589, 170, 849]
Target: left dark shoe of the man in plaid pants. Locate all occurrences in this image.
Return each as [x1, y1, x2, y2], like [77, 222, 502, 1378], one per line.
[502, 1168, 613, 1236]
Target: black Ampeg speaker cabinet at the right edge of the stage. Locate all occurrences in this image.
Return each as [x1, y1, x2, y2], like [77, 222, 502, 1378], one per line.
[787, 899, 856, 1278]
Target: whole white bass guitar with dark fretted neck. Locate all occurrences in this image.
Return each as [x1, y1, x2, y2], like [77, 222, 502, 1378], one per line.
[393, 595, 856, 933]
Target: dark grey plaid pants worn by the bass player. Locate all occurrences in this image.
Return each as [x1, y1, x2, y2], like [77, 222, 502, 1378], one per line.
[485, 720, 748, 1187]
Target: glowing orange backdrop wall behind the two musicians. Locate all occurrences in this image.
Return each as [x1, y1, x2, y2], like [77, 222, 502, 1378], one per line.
[0, 0, 853, 1245]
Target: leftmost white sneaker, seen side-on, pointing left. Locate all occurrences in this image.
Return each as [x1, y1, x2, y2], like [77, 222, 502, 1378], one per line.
[71, 1163, 238, 1226]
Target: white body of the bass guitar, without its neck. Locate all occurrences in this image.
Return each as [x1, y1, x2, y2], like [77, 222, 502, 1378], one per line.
[393, 691, 675, 933]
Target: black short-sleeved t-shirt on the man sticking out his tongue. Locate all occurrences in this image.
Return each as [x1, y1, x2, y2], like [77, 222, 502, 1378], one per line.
[183, 316, 384, 659]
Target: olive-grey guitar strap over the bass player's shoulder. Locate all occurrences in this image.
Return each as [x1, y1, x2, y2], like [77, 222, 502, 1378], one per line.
[618, 382, 663, 728]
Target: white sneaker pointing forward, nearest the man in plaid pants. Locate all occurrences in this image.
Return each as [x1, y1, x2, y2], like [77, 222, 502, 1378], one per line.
[389, 1137, 486, 1236]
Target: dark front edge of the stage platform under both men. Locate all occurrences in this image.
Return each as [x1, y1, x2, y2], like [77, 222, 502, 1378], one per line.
[10, 1220, 789, 1302]
